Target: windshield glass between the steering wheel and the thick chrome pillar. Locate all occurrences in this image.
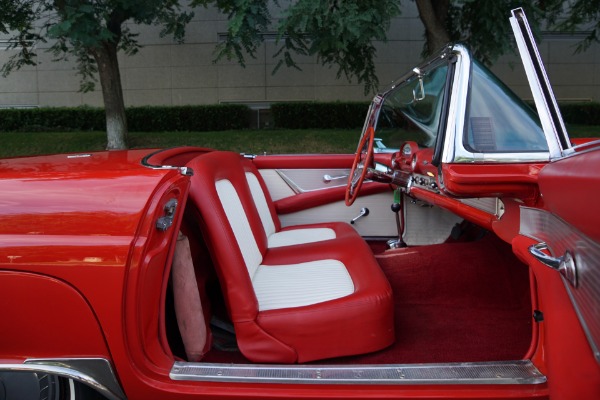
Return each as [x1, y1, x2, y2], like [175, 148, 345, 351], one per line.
[375, 63, 448, 147]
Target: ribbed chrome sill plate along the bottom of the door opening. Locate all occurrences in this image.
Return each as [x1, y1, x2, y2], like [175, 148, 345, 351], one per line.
[170, 360, 546, 385]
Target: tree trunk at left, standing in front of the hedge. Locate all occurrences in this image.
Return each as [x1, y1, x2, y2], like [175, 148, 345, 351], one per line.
[90, 42, 127, 150]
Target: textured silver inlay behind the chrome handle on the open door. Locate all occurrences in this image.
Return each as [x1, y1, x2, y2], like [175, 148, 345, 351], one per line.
[520, 207, 600, 363]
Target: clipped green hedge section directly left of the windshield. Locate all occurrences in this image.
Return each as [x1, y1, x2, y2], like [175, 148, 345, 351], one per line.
[271, 102, 369, 129]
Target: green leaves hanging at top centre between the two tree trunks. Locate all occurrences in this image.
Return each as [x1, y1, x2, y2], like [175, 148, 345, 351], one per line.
[192, 0, 400, 93]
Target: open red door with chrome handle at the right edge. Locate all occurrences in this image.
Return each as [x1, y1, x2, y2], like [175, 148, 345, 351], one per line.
[513, 149, 600, 399]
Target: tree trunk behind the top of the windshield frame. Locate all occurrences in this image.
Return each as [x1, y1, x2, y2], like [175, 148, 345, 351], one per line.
[415, 0, 450, 54]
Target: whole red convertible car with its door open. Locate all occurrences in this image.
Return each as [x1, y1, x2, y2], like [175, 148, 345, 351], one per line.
[0, 9, 600, 400]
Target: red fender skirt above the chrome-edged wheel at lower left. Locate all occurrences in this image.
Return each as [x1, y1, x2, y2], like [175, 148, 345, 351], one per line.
[0, 271, 110, 359]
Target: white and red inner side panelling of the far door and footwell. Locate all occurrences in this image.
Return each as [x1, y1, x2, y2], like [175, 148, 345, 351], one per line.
[255, 154, 462, 245]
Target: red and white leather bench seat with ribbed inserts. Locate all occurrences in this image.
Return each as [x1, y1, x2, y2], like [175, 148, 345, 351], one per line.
[188, 151, 394, 363]
